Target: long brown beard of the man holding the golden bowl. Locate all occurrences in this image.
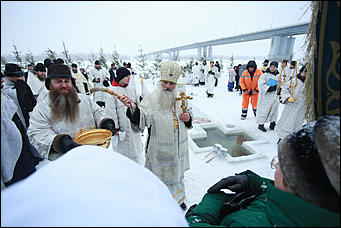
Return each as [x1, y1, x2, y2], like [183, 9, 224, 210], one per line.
[49, 87, 80, 123]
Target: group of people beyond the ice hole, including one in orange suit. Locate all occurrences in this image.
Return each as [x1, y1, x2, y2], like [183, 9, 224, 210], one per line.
[189, 59, 307, 140]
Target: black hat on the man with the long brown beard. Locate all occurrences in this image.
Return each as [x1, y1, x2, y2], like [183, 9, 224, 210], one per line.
[45, 63, 75, 90]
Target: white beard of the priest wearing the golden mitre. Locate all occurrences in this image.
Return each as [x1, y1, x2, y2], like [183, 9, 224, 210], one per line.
[154, 83, 177, 110]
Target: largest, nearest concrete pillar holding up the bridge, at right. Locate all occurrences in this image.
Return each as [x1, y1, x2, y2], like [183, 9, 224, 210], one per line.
[268, 36, 295, 62]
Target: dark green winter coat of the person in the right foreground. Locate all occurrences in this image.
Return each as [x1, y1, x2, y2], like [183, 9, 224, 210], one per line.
[186, 170, 340, 227]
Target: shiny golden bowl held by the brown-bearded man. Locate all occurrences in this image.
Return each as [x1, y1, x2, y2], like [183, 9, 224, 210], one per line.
[73, 126, 112, 148]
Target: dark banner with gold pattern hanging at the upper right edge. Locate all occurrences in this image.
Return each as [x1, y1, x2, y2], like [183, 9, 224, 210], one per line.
[314, 1, 340, 118]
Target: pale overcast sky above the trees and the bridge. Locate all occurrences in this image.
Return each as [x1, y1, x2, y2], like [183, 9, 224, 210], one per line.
[1, 1, 311, 56]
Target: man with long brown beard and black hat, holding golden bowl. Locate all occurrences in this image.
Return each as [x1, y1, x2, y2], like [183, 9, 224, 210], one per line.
[27, 64, 115, 160]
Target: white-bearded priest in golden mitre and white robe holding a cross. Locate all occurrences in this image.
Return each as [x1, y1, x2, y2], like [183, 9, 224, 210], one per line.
[120, 62, 192, 210]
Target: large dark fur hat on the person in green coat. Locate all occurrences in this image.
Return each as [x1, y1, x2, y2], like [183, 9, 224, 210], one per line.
[278, 116, 340, 210]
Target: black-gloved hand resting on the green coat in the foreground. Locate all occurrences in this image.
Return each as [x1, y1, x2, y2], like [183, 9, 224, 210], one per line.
[207, 175, 250, 193]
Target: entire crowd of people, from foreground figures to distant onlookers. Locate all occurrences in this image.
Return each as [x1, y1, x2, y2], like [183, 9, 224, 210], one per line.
[1, 58, 340, 226]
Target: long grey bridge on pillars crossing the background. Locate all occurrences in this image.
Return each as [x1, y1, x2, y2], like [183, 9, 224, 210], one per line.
[146, 22, 310, 61]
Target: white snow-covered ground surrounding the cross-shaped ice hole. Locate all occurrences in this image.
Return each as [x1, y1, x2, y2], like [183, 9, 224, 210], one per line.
[135, 70, 283, 210]
